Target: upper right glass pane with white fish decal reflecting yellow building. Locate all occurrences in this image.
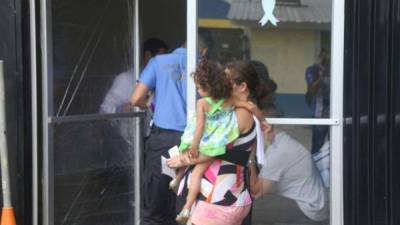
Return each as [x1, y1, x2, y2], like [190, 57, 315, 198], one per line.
[198, 0, 332, 118]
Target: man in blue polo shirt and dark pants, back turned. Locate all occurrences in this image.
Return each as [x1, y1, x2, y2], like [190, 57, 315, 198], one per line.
[131, 39, 207, 225]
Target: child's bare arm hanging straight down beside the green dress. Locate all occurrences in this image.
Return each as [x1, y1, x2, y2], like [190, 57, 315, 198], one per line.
[190, 99, 205, 158]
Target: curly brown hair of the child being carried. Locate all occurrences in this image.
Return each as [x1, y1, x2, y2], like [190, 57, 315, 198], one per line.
[193, 59, 232, 99]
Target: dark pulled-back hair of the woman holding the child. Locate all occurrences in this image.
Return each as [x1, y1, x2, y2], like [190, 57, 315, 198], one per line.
[227, 61, 277, 109]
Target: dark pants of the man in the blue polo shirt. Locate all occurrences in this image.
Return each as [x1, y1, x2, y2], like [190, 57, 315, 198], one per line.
[143, 126, 182, 225]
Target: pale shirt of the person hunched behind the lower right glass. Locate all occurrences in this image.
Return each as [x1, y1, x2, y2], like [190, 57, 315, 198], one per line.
[259, 131, 329, 221]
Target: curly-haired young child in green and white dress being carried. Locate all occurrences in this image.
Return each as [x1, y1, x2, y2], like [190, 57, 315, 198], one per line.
[170, 60, 263, 224]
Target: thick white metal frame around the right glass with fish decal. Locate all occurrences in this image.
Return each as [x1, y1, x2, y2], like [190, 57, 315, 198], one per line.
[187, 0, 345, 225]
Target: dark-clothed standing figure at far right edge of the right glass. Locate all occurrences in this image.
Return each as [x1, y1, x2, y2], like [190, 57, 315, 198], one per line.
[305, 49, 331, 154]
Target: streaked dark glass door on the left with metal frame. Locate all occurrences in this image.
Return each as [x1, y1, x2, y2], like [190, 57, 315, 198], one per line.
[39, 0, 143, 225]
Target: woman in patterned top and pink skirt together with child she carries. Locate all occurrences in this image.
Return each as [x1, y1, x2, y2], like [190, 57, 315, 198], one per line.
[168, 61, 276, 225]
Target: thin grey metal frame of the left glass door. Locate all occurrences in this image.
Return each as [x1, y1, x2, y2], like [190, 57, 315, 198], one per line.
[34, 0, 144, 225]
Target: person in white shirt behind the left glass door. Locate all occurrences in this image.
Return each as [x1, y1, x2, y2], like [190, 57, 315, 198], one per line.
[99, 38, 168, 167]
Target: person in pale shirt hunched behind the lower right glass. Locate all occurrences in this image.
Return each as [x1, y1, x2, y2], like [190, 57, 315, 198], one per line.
[249, 105, 329, 225]
